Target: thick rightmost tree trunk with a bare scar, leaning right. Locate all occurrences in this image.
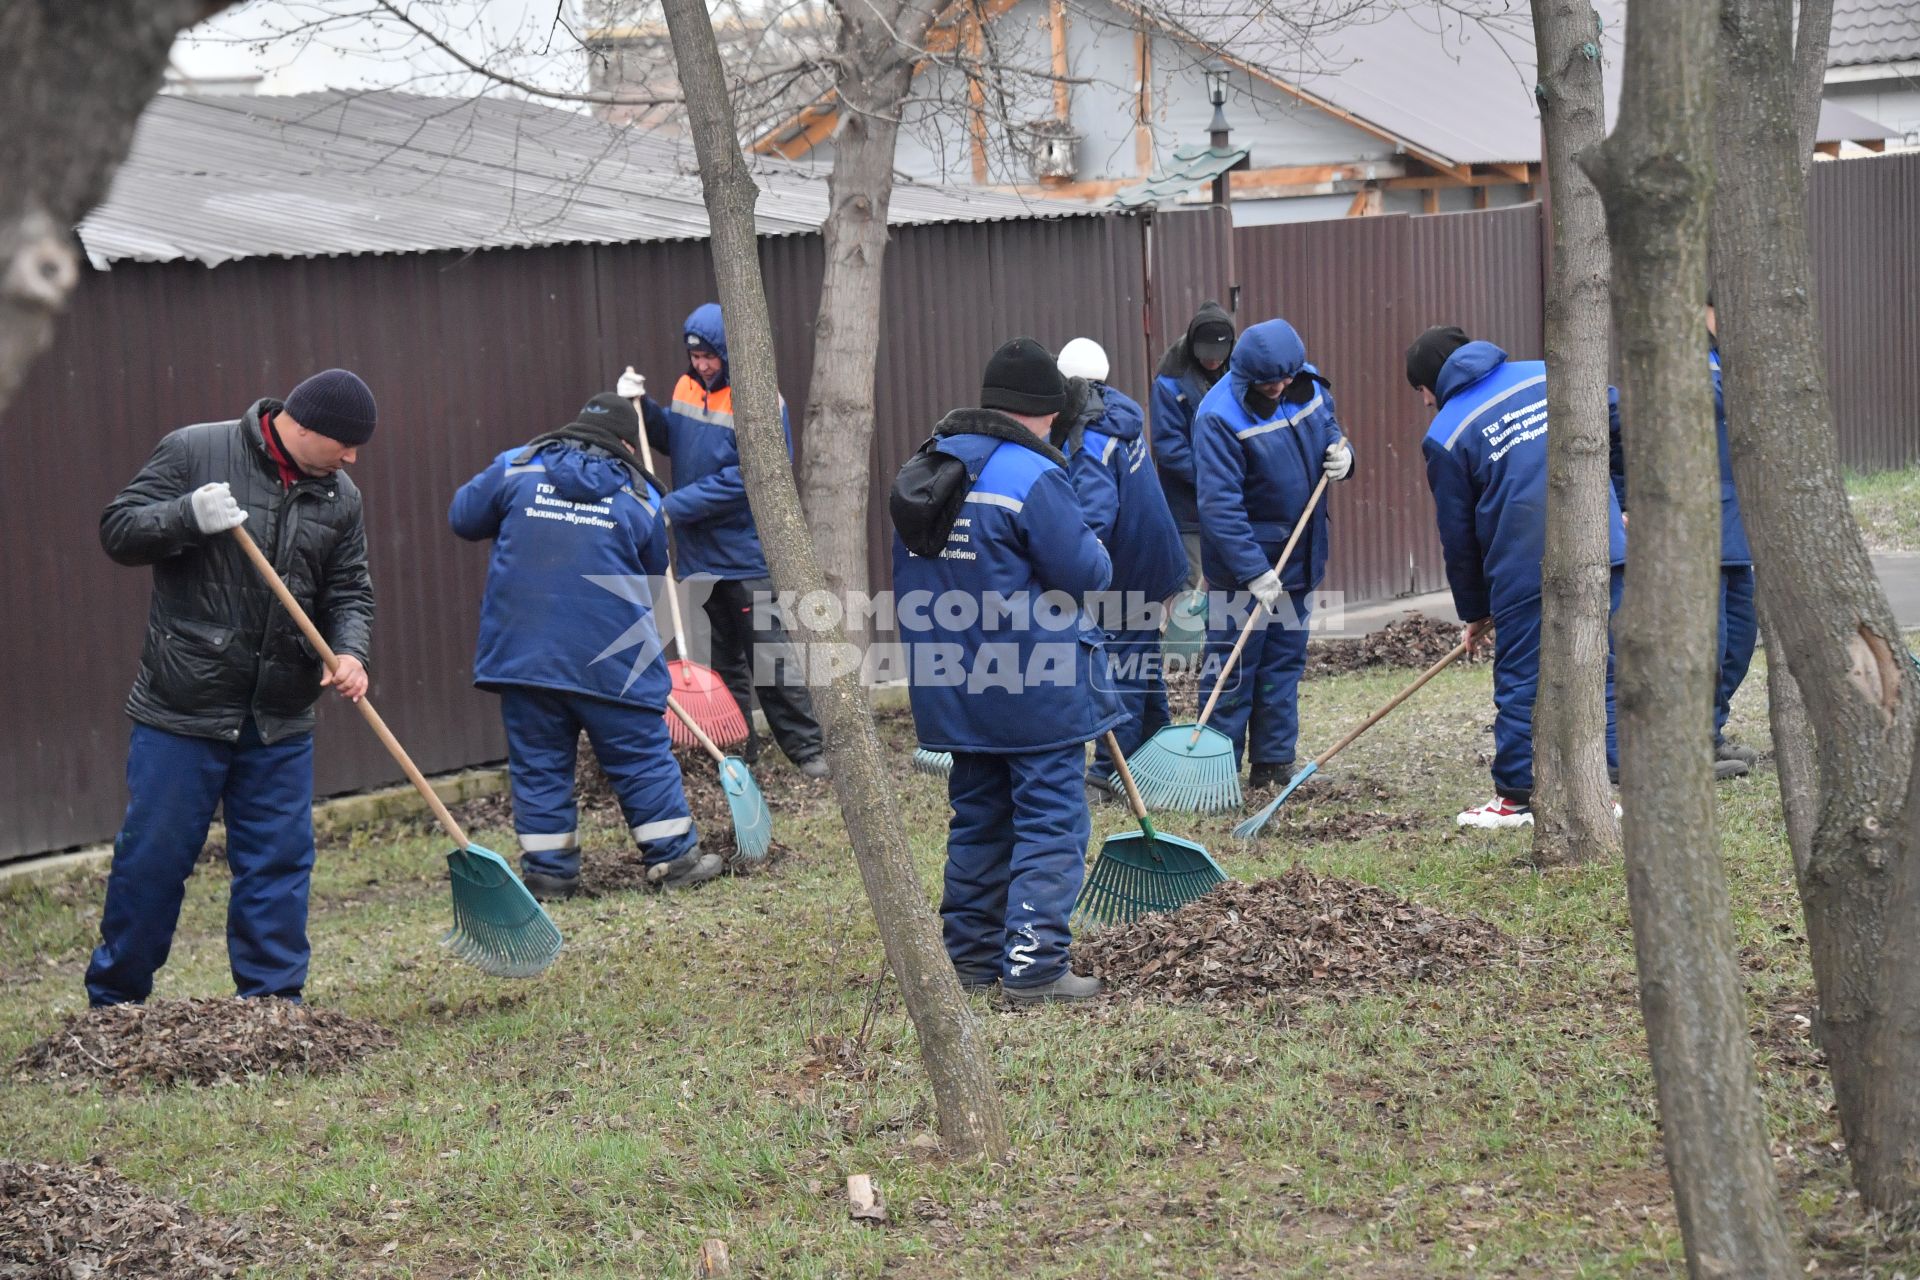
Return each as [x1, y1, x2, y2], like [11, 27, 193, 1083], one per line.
[1713, 0, 1920, 1207]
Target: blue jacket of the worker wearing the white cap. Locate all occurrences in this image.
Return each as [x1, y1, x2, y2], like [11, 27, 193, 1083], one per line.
[1062, 382, 1187, 614]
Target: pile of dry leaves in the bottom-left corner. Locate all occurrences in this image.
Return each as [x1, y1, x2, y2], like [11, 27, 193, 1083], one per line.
[0, 1159, 267, 1280]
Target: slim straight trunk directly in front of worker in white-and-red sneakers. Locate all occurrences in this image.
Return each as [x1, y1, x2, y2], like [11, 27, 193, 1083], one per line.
[1532, 0, 1620, 865]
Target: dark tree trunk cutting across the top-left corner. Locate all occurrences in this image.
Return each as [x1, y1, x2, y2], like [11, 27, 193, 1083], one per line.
[0, 0, 228, 409]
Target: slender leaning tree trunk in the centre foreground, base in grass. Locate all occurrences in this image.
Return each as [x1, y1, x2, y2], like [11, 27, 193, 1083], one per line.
[664, 0, 1008, 1155]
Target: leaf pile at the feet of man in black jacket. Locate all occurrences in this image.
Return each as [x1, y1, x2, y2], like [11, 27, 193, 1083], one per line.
[14, 1000, 396, 1090]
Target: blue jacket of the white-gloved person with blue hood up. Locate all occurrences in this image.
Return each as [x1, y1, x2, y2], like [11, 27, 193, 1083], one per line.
[1194, 320, 1340, 591]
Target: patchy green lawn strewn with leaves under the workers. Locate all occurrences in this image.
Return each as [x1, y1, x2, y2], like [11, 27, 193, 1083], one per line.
[0, 668, 1916, 1280]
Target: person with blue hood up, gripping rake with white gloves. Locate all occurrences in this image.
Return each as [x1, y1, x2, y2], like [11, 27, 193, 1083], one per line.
[1194, 320, 1354, 787]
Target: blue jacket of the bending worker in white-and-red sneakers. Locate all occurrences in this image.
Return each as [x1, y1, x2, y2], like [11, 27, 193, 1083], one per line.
[1421, 342, 1626, 624]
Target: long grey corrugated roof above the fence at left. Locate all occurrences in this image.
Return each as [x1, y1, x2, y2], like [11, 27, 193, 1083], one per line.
[79, 92, 1089, 267]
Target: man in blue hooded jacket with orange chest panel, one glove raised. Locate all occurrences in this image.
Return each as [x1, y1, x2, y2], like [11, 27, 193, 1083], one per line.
[616, 303, 828, 777]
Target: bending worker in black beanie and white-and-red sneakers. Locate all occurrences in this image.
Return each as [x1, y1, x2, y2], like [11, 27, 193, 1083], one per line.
[1407, 326, 1626, 829]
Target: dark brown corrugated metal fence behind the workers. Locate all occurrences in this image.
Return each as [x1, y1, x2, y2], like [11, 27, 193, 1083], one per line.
[0, 157, 1920, 860]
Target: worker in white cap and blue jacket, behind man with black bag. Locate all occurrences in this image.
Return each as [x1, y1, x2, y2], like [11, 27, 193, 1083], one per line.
[1048, 338, 1187, 802]
